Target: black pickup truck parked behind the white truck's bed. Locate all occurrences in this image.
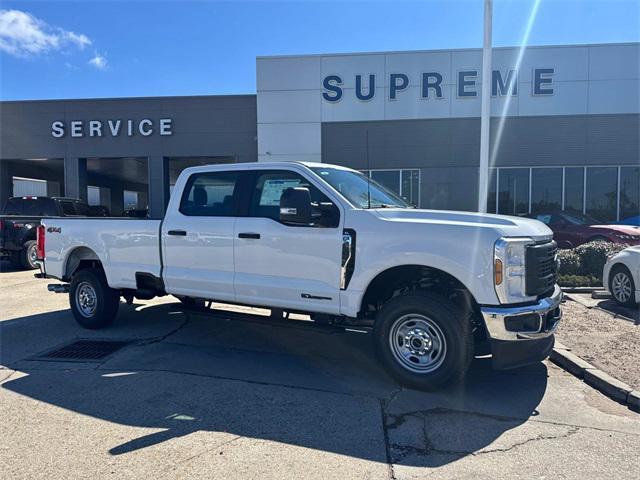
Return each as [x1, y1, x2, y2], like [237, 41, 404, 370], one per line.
[0, 197, 92, 269]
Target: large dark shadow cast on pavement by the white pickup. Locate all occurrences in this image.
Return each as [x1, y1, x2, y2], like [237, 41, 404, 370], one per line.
[0, 304, 547, 466]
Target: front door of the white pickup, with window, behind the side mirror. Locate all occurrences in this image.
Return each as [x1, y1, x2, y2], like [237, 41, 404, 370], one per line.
[234, 170, 343, 313]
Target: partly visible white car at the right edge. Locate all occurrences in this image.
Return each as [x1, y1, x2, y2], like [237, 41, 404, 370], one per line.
[602, 246, 640, 307]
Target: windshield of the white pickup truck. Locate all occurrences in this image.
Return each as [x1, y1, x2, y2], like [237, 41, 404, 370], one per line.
[311, 167, 413, 208]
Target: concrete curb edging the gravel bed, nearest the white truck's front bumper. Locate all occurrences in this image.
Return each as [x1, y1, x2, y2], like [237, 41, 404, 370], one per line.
[549, 344, 640, 413]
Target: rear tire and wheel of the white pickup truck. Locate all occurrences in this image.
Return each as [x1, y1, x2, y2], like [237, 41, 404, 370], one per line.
[69, 269, 120, 330]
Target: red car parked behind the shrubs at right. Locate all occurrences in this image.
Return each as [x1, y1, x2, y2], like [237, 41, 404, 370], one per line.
[527, 211, 640, 248]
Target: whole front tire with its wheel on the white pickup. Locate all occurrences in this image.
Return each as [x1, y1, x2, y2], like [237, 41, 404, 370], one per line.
[374, 292, 473, 390]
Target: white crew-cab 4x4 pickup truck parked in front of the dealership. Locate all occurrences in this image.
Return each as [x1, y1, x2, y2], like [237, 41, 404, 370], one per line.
[38, 162, 562, 389]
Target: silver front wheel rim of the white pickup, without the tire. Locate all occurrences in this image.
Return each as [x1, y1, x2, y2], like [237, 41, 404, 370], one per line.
[389, 314, 447, 373]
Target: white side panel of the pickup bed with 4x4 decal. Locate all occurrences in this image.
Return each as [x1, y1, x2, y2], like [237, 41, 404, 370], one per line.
[42, 218, 161, 288]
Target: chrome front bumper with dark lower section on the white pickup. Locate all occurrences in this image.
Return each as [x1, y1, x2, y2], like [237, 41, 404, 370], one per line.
[480, 285, 562, 369]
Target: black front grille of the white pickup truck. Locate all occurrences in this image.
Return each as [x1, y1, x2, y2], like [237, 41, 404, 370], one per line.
[525, 241, 558, 296]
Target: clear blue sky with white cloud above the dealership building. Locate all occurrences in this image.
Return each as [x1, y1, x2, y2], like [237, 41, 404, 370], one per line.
[0, 0, 640, 100]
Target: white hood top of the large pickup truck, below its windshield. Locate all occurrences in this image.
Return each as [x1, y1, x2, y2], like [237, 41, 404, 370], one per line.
[374, 208, 553, 241]
